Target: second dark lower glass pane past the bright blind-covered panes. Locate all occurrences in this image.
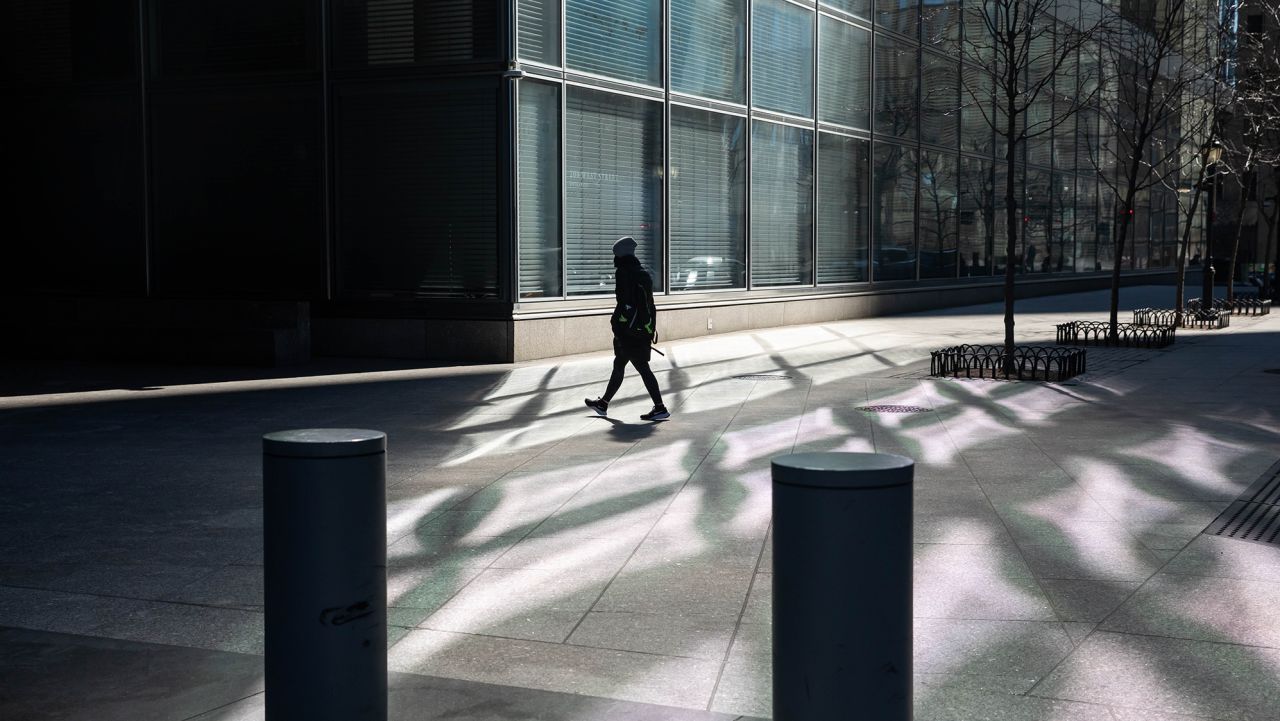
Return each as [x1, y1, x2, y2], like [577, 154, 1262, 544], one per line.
[919, 150, 960, 278]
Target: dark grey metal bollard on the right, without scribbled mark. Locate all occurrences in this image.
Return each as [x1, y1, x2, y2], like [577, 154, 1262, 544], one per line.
[773, 453, 915, 721]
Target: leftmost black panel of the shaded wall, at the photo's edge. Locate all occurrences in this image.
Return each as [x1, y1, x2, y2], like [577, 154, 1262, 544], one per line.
[0, 0, 145, 293]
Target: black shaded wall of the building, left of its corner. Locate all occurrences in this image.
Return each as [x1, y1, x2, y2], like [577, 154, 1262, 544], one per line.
[0, 0, 509, 318]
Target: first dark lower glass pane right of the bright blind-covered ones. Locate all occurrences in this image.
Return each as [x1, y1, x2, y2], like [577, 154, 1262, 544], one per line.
[872, 142, 915, 280]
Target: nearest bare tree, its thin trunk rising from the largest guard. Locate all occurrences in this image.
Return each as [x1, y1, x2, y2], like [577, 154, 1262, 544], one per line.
[961, 0, 1102, 373]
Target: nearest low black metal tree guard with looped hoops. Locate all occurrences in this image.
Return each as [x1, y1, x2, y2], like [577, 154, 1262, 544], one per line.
[929, 344, 1084, 380]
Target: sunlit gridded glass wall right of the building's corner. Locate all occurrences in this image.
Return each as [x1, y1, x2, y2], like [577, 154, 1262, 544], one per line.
[504, 0, 1176, 298]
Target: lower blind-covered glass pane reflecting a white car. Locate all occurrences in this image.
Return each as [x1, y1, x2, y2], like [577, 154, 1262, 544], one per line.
[671, 106, 746, 291]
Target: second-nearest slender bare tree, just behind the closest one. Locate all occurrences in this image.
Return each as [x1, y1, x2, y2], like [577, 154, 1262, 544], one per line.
[1091, 0, 1228, 338]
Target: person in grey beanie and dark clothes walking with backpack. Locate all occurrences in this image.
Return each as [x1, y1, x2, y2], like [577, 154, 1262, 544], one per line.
[586, 236, 671, 420]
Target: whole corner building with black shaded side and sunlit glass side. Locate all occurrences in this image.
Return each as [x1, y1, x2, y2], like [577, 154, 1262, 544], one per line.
[0, 0, 1176, 362]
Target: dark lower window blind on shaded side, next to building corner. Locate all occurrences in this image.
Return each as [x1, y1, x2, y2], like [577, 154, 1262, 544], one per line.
[335, 81, 498, 297]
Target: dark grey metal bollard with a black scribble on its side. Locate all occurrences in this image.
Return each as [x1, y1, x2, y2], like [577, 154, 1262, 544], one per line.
[262, 429, 387, 721]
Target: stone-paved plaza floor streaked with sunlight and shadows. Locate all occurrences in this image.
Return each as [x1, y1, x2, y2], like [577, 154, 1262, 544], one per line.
[0, 288, 1280, 721]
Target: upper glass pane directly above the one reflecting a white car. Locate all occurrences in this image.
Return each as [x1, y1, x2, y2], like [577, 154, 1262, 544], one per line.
[671, 0, 746, 102]
